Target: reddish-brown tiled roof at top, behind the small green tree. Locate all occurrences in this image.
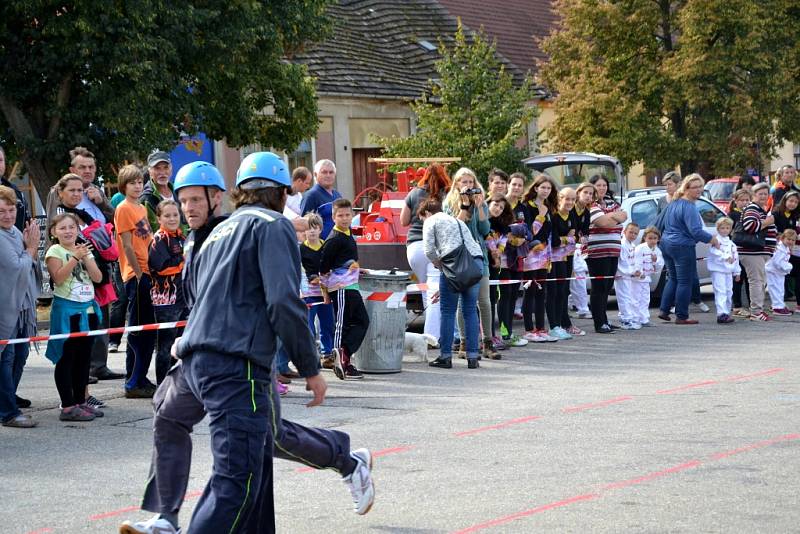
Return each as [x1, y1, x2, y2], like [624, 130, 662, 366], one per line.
[439, 0, 558, 72]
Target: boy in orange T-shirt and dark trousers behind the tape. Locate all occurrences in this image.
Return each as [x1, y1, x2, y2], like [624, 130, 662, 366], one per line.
[114, 165, 156, 399]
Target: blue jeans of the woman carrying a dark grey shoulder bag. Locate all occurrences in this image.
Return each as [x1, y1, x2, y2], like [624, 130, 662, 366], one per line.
[439, 260, 483, 359]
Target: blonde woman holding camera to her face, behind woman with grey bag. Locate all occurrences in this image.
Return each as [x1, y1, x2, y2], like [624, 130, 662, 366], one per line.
[443, 167, 500, 360]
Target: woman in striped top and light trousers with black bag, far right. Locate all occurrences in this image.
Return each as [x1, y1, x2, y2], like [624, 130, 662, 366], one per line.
[734, 182, 778, 321]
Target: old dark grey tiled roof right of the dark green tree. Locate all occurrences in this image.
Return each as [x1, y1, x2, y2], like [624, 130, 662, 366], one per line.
[292, 0, 548, 99]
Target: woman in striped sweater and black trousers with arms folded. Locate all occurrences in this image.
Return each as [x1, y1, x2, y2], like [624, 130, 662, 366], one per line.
[586, 174, 628, 334]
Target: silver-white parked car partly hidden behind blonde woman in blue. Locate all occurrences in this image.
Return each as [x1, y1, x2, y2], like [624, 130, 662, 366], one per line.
[622, 187, 726, 298]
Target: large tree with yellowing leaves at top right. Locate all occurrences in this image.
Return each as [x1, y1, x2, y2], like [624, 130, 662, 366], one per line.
[540, 0, 800, 174]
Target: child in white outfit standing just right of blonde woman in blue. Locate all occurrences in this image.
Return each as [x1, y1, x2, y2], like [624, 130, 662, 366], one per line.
[706, 217, 742, 324]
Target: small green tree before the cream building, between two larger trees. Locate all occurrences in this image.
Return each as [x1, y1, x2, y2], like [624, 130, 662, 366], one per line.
[378, 23, 536, 183]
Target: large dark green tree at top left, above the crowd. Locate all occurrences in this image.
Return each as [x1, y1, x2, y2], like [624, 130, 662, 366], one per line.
[0, 0, 329, 191]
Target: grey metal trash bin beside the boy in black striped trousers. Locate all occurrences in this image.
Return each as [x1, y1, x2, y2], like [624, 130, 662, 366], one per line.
[355, 270, 411, 374]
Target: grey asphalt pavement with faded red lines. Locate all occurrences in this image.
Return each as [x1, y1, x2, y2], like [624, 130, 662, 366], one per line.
[0, 303, 800, 534]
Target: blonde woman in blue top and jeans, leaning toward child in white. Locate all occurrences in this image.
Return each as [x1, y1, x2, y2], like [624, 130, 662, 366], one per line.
[658, 174, 719, 325]
